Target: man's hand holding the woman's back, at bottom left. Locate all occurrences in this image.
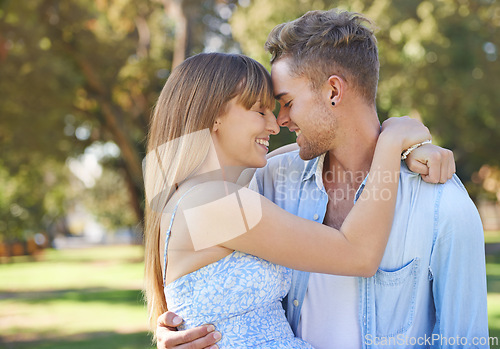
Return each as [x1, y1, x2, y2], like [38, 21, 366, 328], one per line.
[156, 311, 221, 349]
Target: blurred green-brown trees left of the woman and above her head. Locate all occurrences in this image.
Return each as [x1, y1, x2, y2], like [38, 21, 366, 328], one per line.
[0, 0, 242, 241]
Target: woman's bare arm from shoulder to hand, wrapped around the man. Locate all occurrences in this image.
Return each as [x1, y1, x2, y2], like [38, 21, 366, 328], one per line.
[182, 118, 430, 276]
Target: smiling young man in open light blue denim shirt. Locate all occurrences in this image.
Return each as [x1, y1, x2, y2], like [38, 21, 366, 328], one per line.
[154, 10, 488, 349]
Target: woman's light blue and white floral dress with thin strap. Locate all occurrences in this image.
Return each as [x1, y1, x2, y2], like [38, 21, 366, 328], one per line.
[163, 196, 312, 349]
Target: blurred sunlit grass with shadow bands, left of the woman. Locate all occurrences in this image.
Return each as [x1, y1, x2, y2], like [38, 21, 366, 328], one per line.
[0, 246, 151, 349]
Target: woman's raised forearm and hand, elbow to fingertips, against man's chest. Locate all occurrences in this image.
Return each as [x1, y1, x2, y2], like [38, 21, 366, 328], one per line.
[340, 117, 431, 274]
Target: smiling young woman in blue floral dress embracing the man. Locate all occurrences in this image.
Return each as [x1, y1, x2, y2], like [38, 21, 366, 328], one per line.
[145, 53, 438, 348]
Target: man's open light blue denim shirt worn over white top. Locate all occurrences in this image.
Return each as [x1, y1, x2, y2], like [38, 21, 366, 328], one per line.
[250, 151, 489, 348]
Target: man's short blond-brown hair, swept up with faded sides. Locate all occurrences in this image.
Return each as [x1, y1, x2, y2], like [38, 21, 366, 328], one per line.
[265, 9, 379, 104]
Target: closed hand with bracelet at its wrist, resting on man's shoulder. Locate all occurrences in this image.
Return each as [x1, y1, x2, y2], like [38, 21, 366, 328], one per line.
[405, 144, 455, 183]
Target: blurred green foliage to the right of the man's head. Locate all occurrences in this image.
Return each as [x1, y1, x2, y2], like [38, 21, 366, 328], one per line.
[379, 1, 500, 179]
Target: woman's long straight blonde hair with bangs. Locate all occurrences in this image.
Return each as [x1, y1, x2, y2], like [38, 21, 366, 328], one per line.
[144, 53, 275, 334]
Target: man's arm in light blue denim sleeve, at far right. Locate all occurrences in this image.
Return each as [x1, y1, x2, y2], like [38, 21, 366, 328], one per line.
[430, 176, 489, 348]
